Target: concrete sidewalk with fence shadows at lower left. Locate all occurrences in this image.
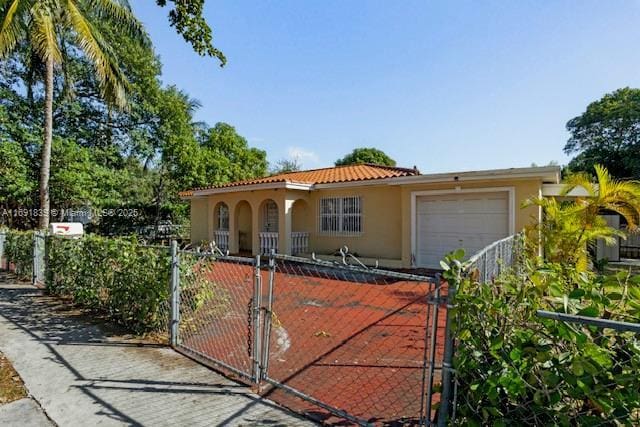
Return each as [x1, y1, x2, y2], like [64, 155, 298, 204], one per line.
[0, 273, 315, 426]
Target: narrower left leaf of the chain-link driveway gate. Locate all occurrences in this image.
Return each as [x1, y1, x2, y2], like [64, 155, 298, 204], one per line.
[171, 244, 261, 383]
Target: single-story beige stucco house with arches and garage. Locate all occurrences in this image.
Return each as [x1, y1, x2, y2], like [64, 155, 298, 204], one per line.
[180, 164, 560, 268]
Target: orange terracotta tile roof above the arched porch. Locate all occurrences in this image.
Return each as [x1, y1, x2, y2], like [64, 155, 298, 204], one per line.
[180, 164, 420, 197]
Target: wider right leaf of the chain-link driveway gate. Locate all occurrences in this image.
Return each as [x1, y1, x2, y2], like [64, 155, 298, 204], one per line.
[261, 255, 446, 425]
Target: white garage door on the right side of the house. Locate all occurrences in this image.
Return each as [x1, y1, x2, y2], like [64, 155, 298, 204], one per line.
[416, 191, 509, 268]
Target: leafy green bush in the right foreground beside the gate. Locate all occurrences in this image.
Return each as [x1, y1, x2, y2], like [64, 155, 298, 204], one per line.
[446, 252, 640, 425]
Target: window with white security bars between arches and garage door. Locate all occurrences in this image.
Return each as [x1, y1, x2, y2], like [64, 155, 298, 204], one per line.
[318, 197, 362, 235]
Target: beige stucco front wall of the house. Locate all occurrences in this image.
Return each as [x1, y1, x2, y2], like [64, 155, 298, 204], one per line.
[191, 179, 542, 267]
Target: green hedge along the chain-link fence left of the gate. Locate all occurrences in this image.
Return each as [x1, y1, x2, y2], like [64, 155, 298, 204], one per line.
[46, 235, 171, 333]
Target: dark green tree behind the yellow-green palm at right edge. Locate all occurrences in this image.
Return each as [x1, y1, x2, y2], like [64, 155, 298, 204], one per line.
[564, 87, 640, 179]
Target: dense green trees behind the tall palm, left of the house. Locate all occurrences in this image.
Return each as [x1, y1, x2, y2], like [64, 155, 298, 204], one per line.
[0, 16, 266, 233]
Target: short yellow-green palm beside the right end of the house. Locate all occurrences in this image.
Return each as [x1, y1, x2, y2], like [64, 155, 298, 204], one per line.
[525, 165, 640, 269]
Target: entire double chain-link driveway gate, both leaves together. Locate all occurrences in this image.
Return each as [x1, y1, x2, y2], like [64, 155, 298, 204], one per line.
[171, 244, 447, 425]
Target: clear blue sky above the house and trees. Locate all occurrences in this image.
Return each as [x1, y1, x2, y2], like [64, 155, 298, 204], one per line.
[133, 0, 640, 172]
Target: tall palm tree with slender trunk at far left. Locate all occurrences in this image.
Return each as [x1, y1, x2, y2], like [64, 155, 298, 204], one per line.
[0, 0, 146, 228]
